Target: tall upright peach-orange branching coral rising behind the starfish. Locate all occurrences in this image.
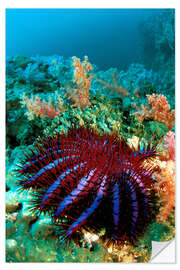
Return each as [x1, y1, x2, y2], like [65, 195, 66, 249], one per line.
[67, 56, 93, 109]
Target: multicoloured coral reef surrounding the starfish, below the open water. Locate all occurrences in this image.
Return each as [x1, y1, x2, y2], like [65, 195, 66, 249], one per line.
[6, 50, 175, 262]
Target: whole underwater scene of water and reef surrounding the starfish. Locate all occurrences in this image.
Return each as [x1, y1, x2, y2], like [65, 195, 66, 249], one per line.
[6, 9, 175, 262]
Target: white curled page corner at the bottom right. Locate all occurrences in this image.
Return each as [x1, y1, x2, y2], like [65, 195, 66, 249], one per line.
[150, 239, 176, 263]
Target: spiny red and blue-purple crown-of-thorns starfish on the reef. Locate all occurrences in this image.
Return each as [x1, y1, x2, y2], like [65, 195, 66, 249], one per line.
[17, 127, 159, 247]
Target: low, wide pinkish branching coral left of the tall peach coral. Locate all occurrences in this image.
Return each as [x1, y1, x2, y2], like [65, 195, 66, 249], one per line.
[21, 93, 64, 120]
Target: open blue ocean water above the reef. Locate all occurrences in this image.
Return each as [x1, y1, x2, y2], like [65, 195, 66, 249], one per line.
[6, 9, 166, 69]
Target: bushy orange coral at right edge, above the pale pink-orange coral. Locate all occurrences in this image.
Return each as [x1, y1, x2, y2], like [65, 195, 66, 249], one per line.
[136, 94, 175, 130]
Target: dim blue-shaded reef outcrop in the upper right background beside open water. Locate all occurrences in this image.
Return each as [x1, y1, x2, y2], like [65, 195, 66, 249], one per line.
[139, 9, 175, 67]
